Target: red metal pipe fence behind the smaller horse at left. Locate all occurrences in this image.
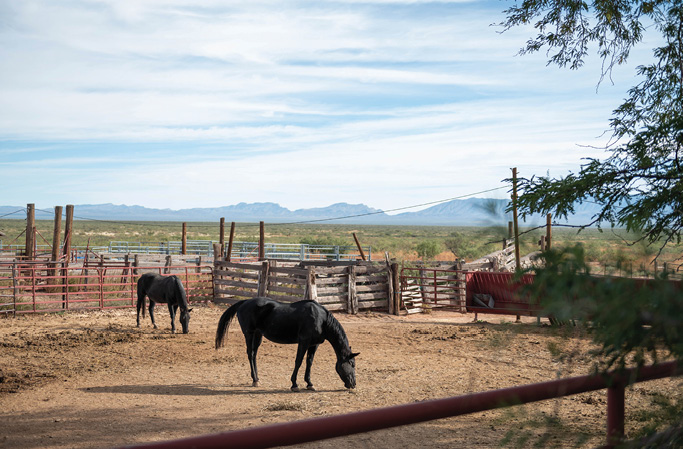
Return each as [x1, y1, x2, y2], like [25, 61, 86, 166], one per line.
[0, 262, 213, 314]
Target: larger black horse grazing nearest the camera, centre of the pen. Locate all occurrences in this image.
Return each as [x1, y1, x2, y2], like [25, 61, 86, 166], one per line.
[216, 298, 358, 391]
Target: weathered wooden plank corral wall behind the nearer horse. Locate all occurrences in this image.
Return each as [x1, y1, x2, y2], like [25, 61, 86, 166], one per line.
[214, 259, 396, 313]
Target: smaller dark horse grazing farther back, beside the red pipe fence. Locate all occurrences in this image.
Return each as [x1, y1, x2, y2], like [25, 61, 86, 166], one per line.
[138, 273, 192, 334]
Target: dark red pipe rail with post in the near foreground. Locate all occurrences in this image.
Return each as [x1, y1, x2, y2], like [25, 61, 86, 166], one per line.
[120, 362, 683, 449]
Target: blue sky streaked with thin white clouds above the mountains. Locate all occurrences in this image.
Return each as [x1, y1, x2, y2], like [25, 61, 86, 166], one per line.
[0, 0, 652, 214]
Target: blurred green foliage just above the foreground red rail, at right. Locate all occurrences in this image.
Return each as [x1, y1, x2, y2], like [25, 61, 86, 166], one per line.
[526, 245, 683, 370]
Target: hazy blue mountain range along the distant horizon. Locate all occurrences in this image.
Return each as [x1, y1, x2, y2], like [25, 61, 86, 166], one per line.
[0, 198, 598, 226]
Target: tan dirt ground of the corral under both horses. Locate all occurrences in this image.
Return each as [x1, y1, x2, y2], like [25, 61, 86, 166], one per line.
[0, 305, 681, 449]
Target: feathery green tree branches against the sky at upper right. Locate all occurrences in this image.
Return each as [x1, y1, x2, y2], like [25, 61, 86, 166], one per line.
[503, 0, 683, 256]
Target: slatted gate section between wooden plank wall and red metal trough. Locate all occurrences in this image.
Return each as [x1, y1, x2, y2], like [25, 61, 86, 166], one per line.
[401, 268, 467, 313]
